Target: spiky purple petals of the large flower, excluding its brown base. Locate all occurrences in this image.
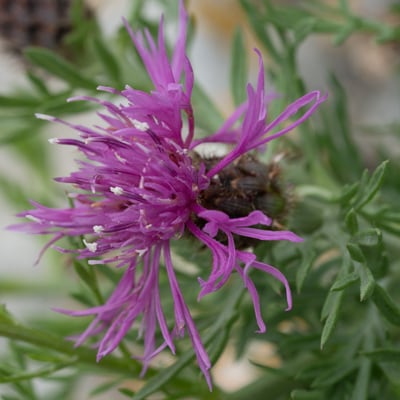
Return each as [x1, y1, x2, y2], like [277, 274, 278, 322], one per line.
[13, 1, 326, 387]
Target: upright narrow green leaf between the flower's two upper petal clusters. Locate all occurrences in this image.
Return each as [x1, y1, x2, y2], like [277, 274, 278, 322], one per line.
[231, 29, 248, 106]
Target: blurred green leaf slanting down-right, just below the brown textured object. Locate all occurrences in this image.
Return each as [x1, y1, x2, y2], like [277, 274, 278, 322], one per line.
[24, 47, 98, 90]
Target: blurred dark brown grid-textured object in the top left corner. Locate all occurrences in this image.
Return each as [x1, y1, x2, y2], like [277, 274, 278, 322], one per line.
[0, 0, 90, 53]
